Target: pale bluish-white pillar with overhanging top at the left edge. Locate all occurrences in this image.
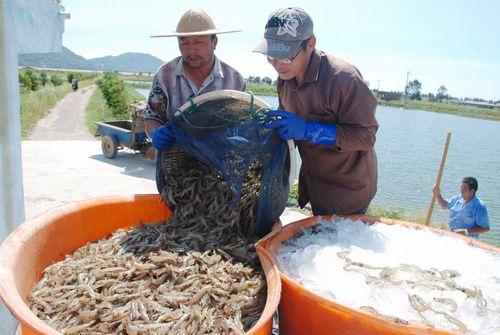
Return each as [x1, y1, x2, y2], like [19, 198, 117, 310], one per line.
[0, 0, 67, 335]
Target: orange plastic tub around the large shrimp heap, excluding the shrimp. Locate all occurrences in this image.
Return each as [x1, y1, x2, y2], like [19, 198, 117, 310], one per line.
[0, 195, 281, 335]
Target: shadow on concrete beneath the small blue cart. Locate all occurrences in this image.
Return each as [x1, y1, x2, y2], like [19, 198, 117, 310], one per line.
[89, 151, 156, 180]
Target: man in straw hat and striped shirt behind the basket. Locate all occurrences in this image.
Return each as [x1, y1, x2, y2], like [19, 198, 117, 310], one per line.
[144, 9, 245, 192]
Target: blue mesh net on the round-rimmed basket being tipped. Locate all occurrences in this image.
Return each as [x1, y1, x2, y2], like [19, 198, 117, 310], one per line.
[162, 90, 290, 236]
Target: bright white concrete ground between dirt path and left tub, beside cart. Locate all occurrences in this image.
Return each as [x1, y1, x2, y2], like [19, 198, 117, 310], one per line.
[22, 141, 157, 218]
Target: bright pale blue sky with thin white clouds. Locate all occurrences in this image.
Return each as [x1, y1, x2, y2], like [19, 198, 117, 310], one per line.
[62, 0, 500, 100]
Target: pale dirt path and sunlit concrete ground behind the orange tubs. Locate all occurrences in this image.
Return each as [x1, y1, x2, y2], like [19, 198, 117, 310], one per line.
[22, 86, 303, 222]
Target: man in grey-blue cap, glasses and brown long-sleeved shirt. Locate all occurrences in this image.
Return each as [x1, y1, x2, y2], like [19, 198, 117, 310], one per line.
[254, 8, 378, 215]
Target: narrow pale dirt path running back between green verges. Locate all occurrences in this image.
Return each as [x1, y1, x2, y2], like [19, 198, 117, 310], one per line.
[29, 85, 95, 140]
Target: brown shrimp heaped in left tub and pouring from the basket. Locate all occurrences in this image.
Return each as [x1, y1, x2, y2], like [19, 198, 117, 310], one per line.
[28, 162, 267, 335]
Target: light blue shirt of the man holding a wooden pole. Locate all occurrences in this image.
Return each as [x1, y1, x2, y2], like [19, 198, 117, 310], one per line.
[448, 194, 490, 238]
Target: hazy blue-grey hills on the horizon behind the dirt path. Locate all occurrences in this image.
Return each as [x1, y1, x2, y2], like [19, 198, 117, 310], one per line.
[19, 47, 164, 72]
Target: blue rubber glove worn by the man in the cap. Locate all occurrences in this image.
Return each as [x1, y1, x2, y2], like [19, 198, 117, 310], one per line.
[264, 110, 337, 146]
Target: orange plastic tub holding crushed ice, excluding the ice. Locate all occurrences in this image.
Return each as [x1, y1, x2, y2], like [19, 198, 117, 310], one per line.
[259, 215, 500, 335]
